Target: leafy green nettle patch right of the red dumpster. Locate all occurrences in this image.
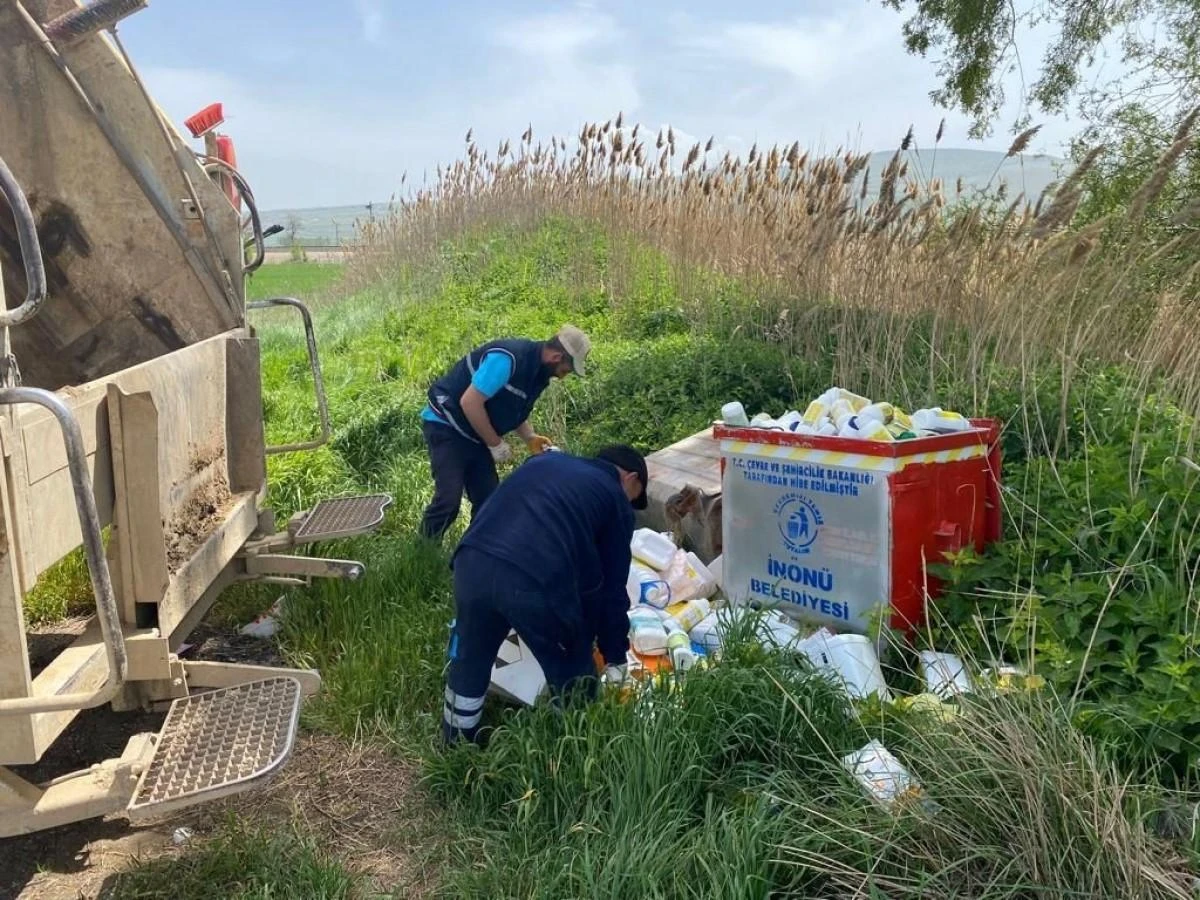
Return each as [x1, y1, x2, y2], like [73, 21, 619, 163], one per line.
[929, 412, 1200, 775]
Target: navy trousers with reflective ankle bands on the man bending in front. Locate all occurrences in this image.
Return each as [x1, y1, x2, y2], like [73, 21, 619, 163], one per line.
[442, 547, 599, 743]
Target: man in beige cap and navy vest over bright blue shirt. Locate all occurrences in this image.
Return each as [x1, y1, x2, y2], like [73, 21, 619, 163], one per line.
[421, 325, 592, 540]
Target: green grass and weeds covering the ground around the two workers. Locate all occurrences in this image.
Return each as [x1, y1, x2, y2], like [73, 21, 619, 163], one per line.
[63, 222, 1198, 898]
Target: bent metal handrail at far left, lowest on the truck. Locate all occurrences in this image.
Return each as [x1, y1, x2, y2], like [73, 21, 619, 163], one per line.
[0, 388, 128, 715]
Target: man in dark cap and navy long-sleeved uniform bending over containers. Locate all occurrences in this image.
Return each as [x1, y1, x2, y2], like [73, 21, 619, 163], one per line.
[442, 444, 647, 743]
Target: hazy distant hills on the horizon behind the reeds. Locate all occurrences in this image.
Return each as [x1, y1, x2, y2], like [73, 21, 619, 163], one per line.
[262, 148, 1069, 247]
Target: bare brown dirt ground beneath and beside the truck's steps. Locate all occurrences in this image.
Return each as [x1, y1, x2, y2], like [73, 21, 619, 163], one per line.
[0, 624, 436, 900]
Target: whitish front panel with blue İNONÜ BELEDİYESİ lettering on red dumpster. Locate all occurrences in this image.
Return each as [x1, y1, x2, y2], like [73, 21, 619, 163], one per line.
[721, 448, 890, 631]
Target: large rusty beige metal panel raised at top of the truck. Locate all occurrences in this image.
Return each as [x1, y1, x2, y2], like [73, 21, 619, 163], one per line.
[0, 0, 244, 390]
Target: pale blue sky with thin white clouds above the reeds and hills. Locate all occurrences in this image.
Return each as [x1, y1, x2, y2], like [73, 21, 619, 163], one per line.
[120, 0, 1094, 209]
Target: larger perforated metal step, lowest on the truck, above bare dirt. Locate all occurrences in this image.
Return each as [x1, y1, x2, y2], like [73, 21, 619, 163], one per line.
[126, 676, 302, 820]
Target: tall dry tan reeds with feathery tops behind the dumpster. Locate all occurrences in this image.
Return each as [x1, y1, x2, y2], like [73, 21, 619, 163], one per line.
[354, 116, 1200, 427]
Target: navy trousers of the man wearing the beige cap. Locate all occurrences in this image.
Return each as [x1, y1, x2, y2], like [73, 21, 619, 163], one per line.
[421, 421, 499, 540]
